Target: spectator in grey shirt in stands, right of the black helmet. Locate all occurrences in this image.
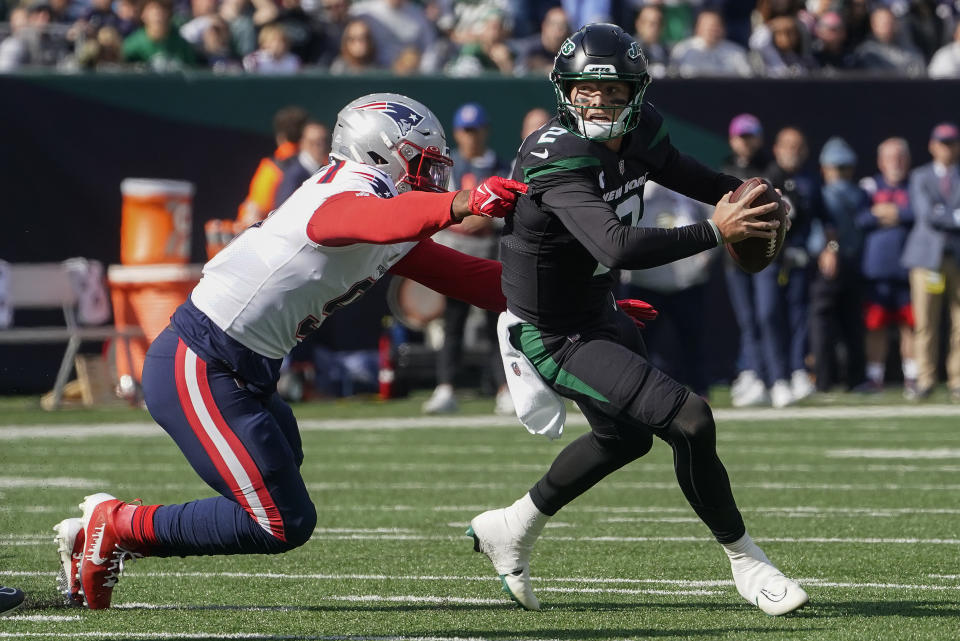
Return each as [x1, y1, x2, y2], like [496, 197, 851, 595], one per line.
[670, 9, 753, 77]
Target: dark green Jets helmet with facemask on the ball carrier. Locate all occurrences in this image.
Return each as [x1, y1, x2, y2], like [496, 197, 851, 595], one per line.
[550, 23, 650, 142]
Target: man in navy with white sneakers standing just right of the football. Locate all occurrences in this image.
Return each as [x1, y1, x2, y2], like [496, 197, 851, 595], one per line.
[753, 127, 821, 407]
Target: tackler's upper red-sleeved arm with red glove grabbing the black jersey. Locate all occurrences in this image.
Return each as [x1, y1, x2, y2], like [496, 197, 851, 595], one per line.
[307, 176, 526, 247]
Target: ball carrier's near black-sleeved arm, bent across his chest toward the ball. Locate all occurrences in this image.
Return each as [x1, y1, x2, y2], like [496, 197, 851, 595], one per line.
[542, 173, 717, 269]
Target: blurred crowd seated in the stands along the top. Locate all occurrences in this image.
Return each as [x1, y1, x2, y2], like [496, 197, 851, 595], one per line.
[0, 0, 960, 78]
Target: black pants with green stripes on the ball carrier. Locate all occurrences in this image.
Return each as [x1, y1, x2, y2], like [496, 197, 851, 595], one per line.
[511, 301, 745, 543]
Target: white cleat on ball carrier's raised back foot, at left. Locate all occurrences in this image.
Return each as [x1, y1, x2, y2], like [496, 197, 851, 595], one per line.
[467, 508, 540, 610]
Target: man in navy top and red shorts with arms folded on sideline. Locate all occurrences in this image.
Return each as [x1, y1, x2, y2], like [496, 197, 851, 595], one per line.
[857, 138, 917, 392]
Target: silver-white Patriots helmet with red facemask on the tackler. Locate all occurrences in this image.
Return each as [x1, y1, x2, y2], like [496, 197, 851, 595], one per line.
[330, 93, 453, 193]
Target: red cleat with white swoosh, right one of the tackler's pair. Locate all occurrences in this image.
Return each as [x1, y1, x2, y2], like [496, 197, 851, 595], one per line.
[80, 492, 143, 610]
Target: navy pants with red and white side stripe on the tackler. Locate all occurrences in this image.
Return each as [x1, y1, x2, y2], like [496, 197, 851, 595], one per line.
[143, 328, 317, 556]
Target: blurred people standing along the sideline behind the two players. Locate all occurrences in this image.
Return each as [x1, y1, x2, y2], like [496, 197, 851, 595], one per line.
[234, 102, 960, 414]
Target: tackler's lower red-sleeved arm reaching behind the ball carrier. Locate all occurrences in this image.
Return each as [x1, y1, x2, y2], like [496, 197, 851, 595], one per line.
[389, 238, 507, 312]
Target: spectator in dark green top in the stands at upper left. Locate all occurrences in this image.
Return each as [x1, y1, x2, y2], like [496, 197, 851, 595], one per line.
[123, 0, 197, 71]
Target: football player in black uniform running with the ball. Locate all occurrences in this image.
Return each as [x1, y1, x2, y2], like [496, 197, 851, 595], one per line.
[468, 24, 807, 614]
